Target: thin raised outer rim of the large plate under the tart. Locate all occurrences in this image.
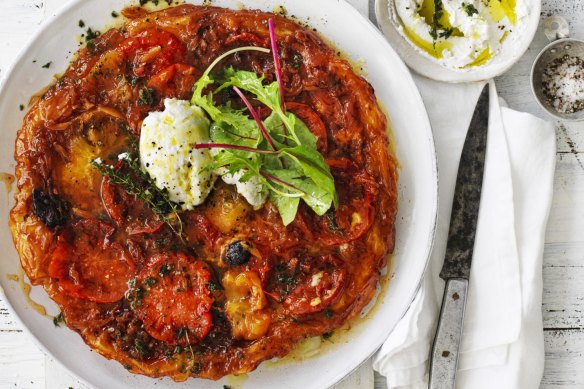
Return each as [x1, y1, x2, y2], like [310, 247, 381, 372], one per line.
[0, 0, 439, 387]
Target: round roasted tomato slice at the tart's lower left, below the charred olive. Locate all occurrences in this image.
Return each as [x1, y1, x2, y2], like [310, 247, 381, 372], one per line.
[49, 219, 135, 303]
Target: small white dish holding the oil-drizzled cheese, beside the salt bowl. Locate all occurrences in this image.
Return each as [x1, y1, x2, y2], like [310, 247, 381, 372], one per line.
[375, 0, 541, 82]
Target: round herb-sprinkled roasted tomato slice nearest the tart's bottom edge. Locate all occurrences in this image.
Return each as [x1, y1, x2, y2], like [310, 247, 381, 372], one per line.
[128, 253, 213, 346]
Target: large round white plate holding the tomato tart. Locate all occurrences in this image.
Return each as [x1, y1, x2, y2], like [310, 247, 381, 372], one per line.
[0, 0, 437, 389]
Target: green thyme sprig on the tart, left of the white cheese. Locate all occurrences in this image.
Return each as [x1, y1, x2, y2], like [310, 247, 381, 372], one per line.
[91, 151, 183, 239]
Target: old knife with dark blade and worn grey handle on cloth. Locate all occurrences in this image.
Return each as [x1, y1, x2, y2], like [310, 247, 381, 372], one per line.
[429, 84, 489, 389]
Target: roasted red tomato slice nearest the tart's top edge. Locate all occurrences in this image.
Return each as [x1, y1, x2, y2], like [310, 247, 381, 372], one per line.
[118, 28, 186, 77]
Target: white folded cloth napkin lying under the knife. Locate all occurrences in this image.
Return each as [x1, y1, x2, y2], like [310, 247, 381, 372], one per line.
[373, 76, 555, 389]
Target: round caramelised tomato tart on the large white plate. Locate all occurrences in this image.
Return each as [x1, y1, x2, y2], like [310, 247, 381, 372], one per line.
[10, 5, 397, 381]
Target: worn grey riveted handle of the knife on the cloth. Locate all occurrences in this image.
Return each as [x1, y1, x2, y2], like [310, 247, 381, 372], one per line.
[429, 278, 468, 389]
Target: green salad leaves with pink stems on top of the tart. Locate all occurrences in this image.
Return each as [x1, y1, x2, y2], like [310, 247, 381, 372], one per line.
[191, 20, 339, 225]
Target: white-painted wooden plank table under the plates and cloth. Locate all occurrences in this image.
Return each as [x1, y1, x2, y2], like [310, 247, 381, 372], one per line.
[0, 0, 584, 389]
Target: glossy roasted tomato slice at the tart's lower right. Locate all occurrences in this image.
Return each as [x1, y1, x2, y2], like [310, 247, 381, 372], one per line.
[283, 255, 347, 315]
